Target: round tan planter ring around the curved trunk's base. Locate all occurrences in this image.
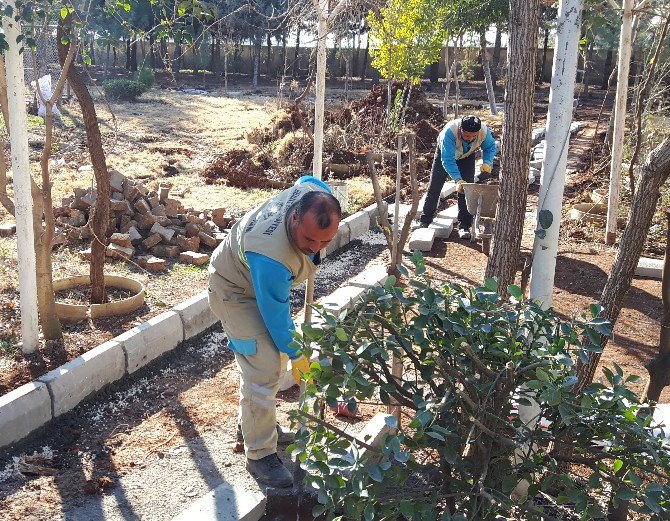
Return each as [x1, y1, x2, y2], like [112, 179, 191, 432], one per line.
[54, 275, 146, 323]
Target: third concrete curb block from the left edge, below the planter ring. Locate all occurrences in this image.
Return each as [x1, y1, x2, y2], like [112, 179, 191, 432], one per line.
[114, 311, 184, 374]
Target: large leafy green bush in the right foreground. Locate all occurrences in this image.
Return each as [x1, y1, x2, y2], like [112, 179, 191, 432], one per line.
[288, 255, 670, 520]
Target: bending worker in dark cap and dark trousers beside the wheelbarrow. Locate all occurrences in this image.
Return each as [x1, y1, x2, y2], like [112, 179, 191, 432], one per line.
[419, 116, 496, 239]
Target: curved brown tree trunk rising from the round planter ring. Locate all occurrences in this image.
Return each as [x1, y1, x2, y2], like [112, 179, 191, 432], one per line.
[56, 14, 110, 304]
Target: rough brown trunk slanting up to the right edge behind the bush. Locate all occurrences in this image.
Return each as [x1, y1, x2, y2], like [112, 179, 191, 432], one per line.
[576, 138, 670, 392]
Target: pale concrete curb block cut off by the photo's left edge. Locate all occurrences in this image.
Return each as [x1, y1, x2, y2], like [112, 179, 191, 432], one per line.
[0, 382, 51, 447]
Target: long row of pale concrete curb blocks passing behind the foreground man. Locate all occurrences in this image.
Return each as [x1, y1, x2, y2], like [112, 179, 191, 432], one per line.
[0, 204, 385, 447]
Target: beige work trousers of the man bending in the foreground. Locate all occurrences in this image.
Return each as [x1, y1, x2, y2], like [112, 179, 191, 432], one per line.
[209, 273, 288, 460]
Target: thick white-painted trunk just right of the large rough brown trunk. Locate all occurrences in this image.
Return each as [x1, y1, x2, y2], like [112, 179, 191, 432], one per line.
[530, 0, 584, 309]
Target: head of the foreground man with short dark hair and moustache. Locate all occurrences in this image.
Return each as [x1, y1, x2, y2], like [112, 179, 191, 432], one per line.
[289, 191, 342, 255]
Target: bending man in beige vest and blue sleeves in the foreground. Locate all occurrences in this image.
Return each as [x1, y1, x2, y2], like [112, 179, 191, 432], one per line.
[209, 176, 342, 487]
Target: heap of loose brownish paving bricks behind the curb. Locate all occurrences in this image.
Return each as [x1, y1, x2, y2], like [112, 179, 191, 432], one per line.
[54, 170, 234, 272]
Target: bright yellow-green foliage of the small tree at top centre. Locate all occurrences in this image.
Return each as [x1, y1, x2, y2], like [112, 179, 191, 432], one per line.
[368, 0, 450, 83]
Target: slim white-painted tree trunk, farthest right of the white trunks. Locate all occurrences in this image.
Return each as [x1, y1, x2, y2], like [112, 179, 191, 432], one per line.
[605, 0, 633, 245]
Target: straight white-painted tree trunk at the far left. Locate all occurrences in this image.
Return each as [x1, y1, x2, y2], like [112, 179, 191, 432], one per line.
[2, 5, 39, 353]
